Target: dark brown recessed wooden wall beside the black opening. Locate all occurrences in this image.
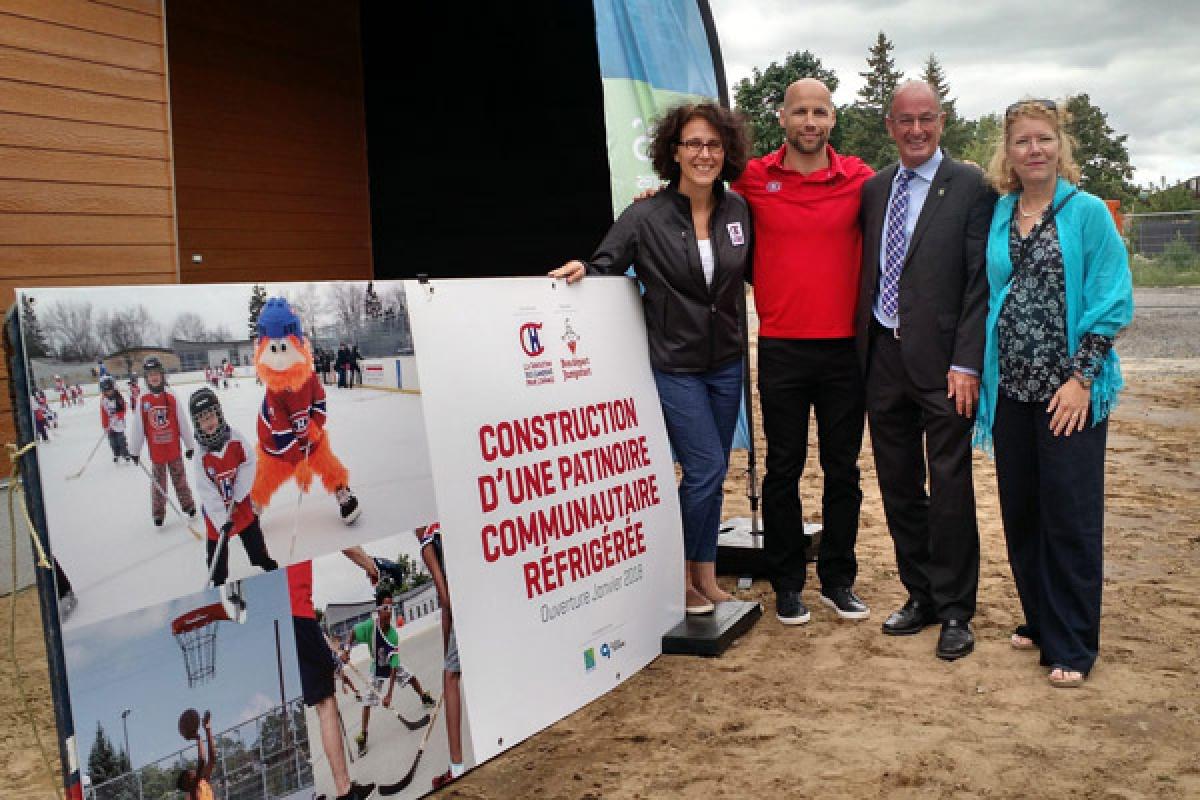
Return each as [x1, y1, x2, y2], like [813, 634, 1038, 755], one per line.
[166, 0, 372, 283]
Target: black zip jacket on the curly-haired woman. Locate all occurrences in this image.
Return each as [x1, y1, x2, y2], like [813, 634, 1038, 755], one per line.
[586, 182, 754, 372]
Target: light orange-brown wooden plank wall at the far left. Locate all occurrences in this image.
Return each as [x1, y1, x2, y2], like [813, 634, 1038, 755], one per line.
[0, 0, 179, 448]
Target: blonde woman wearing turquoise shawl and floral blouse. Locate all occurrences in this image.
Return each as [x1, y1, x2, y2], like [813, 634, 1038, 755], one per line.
[974, 100, 1133, 687]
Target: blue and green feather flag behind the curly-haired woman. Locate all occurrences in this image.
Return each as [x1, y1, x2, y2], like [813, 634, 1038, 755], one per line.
[593, 0, 719, 217]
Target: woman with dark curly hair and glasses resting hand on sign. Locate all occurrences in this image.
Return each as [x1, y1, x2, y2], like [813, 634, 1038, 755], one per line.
[550, 103, 752, 614]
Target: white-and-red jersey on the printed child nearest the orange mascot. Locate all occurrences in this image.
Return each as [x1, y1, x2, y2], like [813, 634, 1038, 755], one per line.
[192, 428, 257, 541]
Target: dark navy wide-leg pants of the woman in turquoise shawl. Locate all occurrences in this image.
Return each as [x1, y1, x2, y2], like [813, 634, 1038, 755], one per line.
[992, 395, 1109, 675]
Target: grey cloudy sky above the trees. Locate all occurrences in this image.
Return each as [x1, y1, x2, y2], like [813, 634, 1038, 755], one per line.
[710, 0, 1200, 184]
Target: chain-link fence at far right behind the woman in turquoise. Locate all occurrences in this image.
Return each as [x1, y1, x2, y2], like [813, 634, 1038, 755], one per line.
[1124, 211, 1200, 285]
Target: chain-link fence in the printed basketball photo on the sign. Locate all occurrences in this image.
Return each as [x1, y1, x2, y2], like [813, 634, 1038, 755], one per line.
[84, 698, 313, 800]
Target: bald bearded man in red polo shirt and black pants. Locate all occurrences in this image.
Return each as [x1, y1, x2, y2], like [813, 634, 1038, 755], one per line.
[733, 78, 874, 625]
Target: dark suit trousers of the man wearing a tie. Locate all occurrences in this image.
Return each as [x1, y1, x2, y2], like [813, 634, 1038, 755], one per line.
[866, 325, 979, 620]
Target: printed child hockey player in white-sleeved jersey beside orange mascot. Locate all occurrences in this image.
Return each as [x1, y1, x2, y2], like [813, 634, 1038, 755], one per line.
[187, 386, 278, 587]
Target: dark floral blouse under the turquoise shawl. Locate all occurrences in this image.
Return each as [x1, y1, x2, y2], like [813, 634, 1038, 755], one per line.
[997, 209, 1112, 403]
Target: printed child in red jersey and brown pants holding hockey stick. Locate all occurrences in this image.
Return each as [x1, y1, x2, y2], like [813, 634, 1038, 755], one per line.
[130, 356, 196, 525]
